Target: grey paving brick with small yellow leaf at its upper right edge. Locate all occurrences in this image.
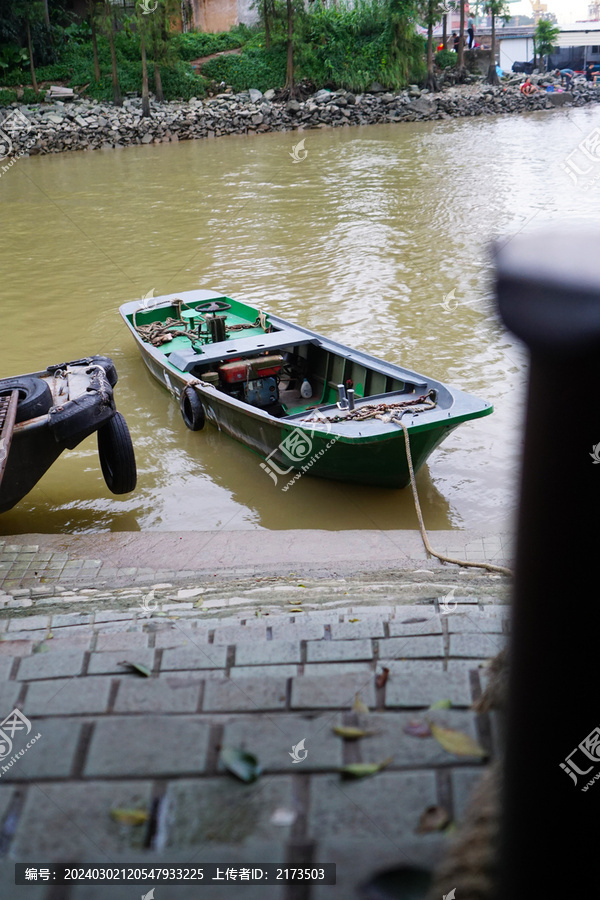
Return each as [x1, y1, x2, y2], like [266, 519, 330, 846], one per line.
[11, 781, 152, 856]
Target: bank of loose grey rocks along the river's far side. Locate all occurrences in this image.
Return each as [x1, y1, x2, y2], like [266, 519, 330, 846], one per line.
[0, 76, 600, 156]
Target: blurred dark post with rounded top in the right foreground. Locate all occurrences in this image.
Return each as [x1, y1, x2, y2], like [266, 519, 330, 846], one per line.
[496, 229, 600, 900]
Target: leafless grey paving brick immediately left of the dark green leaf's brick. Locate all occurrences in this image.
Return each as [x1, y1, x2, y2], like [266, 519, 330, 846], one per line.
[85, 716, 210, 776]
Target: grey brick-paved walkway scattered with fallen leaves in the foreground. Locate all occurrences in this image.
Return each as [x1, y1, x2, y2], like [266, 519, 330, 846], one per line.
[0, 568, 507, 900]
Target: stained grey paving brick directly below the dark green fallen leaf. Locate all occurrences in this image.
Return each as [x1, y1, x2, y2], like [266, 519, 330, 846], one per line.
[165, 775, 294, 848]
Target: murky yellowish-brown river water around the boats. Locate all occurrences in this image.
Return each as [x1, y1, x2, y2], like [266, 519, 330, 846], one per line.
[0, 107, 599, 534]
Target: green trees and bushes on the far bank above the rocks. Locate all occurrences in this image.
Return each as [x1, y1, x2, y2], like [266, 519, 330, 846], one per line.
[0, 0, 520, 113]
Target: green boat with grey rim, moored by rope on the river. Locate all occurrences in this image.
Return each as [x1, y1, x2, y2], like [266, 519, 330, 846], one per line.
[120, 290, 492, 488]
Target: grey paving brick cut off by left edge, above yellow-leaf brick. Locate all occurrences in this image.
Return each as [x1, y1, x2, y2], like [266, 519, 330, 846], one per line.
[0, 718, 81, 781]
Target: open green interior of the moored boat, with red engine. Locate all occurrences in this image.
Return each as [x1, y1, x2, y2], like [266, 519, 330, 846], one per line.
[128, 297, 437, 418]
